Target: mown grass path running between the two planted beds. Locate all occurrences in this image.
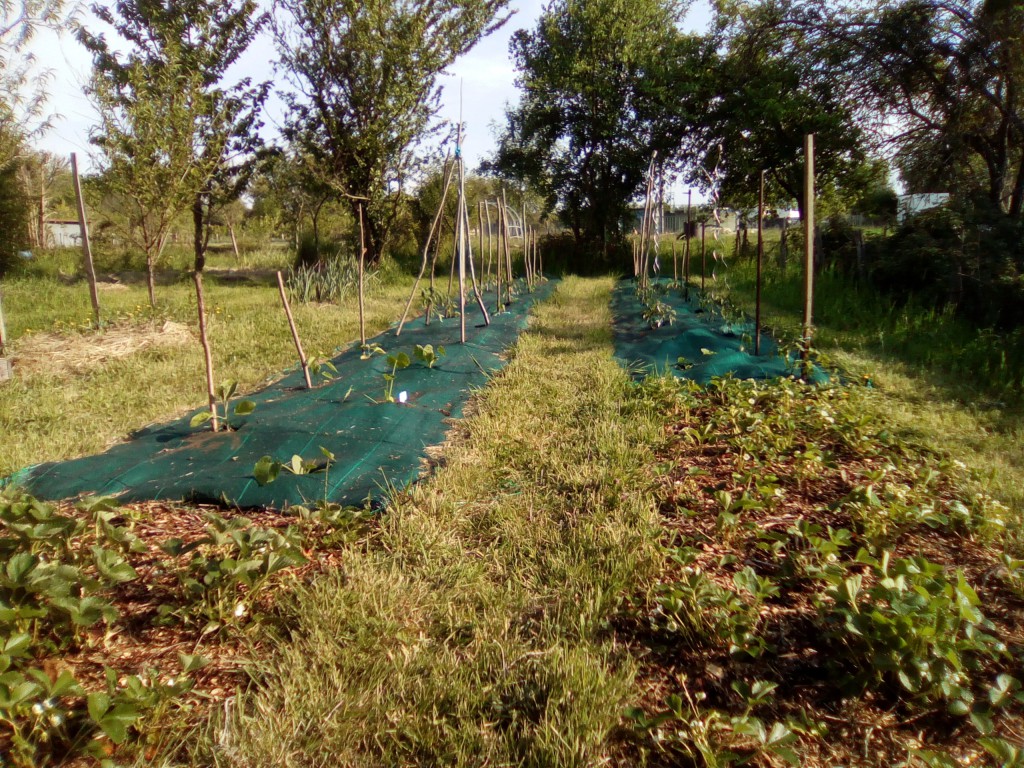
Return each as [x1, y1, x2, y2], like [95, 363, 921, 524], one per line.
[177, 279, 663, 766]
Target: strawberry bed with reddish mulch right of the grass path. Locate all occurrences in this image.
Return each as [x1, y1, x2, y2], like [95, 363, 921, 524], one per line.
[620, 379, 1024, 766]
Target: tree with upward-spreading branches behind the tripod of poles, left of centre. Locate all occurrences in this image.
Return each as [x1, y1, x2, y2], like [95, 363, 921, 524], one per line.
[276, 0, 509, 262]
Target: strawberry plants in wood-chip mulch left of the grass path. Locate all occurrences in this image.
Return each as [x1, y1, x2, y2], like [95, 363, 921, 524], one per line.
[0, 489, 364, 766]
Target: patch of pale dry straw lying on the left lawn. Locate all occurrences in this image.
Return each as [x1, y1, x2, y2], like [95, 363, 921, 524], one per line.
[11, 321, 193, 376]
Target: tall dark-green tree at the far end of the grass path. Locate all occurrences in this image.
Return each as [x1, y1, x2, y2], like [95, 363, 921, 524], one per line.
[488, 0, 708, 256]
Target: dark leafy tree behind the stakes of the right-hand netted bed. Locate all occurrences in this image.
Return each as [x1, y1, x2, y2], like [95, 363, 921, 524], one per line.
[690, 0, 866, 215]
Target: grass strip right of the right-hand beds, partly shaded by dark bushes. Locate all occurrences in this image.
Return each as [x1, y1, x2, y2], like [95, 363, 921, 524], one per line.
[708, 244, 1024, 514]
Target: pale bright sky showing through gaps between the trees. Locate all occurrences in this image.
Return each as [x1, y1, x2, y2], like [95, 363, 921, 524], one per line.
[25, 0, 711, 201]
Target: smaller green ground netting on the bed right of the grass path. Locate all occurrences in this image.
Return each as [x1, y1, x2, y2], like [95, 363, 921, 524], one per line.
[611, 280, 828, 384]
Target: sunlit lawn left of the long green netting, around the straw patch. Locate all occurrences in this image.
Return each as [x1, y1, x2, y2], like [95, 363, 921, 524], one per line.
[0, 253, 411, 476]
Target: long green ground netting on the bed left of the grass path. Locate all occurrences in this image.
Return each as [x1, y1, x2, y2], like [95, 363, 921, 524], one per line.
[7, 283, 554, 509]
